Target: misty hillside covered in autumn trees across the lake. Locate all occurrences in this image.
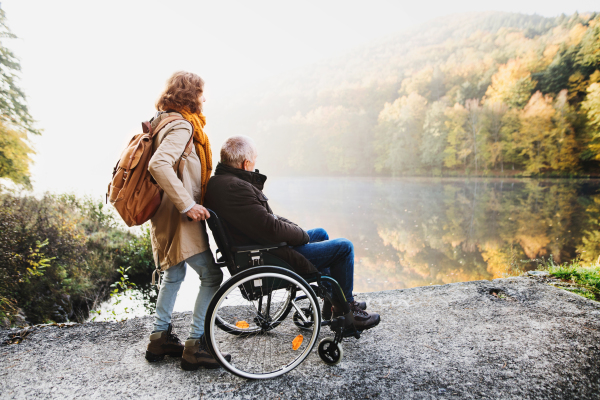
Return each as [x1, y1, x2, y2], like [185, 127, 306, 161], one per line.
[213, 13, 600, 176]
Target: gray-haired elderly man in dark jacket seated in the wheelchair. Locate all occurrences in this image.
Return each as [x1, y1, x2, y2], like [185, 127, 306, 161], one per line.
[204, 136, 380, 330]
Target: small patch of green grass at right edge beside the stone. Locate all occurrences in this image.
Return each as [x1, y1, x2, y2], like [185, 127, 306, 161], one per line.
[540, 258, 600, 301]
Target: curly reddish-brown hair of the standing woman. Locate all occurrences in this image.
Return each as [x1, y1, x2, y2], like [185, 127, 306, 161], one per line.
[156, 71, 204, 113]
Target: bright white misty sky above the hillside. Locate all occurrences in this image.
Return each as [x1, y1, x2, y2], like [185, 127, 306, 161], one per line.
[1, 0, 599, 197]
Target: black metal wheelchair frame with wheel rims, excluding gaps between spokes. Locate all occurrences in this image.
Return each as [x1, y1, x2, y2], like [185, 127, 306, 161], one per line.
[204, 209, 361, 379]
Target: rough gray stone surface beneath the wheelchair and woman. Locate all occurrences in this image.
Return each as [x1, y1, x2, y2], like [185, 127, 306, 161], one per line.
[0, 277, 600, 399]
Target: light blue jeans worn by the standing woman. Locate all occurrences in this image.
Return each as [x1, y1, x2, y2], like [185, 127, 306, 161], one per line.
[153, 250, 223, 339]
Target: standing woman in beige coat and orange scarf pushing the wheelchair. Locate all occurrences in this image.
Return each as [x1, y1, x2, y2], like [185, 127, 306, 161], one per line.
[146, 72, 229, 370]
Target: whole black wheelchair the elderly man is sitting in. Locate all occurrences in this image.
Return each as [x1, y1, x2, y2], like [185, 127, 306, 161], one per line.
[204, 209, 361, 379]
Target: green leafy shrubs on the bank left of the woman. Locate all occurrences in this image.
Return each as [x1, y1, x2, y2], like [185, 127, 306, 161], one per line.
[0, 188, 154, 324]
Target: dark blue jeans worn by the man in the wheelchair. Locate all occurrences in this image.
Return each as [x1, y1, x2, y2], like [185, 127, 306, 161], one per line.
[293, 228, 354, 301]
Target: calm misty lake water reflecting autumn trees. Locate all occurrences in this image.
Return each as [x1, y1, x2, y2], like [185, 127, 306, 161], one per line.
[89, 178, 600, 315]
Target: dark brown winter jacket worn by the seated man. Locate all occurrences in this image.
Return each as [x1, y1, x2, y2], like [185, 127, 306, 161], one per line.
[204, 163, 317, 275]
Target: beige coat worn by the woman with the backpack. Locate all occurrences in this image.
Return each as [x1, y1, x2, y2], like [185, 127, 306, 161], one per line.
[148, 113, 209, 271]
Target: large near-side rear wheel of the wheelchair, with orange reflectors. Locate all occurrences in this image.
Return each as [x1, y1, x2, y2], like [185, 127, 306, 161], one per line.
[204, 266, 321, 379]
